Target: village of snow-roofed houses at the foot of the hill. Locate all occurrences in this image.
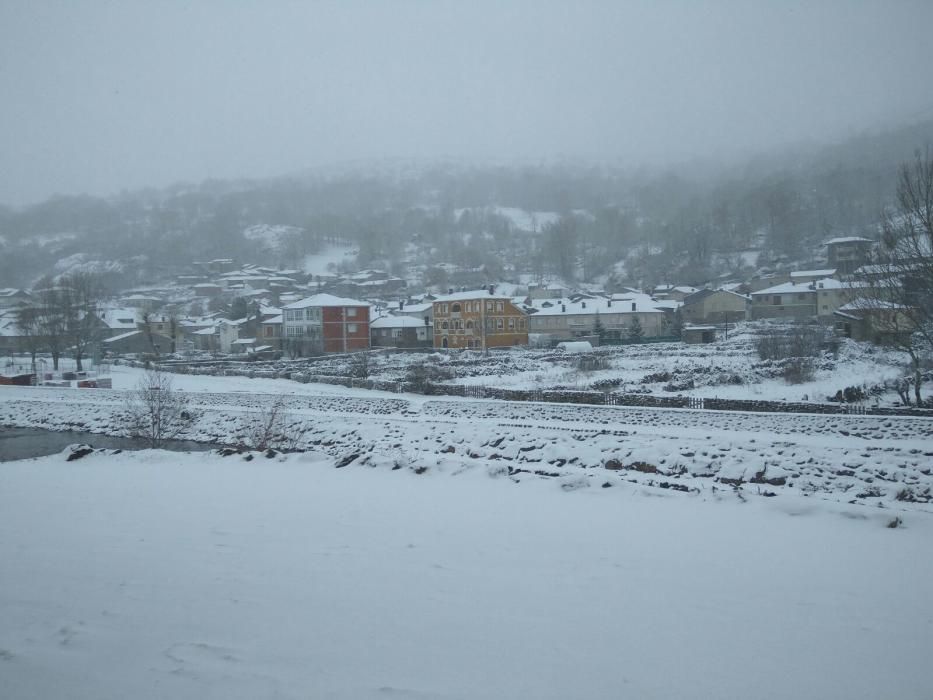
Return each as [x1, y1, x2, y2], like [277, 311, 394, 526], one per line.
[0, 237, 912, 357]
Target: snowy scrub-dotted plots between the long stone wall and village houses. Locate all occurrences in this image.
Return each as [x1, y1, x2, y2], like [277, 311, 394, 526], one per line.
[160, 323, 908, 406]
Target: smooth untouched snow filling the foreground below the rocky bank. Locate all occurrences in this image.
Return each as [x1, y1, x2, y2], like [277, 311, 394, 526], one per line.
[0, 451, 933, 700]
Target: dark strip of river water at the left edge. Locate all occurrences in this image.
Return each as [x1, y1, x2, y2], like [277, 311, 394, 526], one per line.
[0, 427, 219, 462]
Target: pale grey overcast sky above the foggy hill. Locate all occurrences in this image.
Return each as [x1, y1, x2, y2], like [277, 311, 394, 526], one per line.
[0, 0, 933, 205]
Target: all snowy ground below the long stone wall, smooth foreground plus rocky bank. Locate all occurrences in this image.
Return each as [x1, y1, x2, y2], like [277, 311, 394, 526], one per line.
[0, 367, 933, 700]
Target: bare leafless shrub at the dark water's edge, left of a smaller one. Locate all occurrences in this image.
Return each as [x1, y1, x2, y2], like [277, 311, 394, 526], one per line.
[124, 370, 191, 447]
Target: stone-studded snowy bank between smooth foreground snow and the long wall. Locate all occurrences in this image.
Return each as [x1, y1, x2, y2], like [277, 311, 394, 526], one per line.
[0, 367, 933, 508]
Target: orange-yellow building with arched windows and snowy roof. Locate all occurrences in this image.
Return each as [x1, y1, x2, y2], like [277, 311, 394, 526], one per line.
[434, 290, 528, 350]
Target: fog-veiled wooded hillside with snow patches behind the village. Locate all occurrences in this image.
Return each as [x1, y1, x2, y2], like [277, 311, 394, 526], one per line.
[0, 119, 933, 287]
